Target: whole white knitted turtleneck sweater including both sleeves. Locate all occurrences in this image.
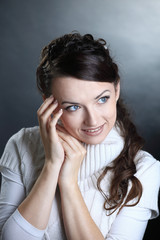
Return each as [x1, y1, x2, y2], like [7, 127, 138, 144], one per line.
[0, 127, 160, 240]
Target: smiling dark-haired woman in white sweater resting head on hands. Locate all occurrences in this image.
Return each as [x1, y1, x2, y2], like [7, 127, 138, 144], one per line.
[0, 33, 160, 240]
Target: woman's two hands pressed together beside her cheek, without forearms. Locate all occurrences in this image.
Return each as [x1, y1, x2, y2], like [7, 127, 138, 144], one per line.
[37, 96, 86, 185]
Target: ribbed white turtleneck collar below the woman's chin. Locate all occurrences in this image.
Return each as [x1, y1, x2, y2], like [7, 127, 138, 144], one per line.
[78, 127, 124, 183]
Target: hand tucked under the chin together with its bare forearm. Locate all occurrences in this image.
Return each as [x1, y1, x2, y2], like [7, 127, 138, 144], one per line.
[57, 125, 104, 240]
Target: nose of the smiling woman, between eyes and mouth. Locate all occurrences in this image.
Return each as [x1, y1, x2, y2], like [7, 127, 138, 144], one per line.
[84, 109, 98, 127]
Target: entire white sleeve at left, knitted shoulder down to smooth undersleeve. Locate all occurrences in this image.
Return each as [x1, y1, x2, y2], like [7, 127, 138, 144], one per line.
[0, 129, 44, 240]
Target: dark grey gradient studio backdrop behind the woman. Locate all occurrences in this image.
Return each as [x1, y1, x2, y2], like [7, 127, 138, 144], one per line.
[0, 0, 160, 239]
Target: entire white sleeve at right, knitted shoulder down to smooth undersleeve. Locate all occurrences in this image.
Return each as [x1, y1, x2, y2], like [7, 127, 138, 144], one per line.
[106, 152, 160, 240]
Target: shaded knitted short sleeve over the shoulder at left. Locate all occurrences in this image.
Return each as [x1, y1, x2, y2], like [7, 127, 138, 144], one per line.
[0, 127, 43, 173]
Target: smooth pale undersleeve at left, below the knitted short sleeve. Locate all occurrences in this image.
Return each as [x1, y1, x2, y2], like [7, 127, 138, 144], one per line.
[0, 168, 44, 240]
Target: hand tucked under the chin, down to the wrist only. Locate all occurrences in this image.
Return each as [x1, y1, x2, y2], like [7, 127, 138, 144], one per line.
[57, 125, 86, 187]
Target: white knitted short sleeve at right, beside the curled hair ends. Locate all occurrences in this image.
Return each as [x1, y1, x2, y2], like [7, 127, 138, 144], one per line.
[135, 151, 160, 218]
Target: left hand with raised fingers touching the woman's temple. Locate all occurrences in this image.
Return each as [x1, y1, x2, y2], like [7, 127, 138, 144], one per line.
[37, 96, 64, 166]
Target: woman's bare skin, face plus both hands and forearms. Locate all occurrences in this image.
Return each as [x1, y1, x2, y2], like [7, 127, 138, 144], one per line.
[18, 78, 120, 240]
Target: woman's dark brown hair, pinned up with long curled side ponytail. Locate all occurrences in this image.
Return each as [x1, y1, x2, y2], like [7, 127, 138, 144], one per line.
[37, 33, 143, 214]
